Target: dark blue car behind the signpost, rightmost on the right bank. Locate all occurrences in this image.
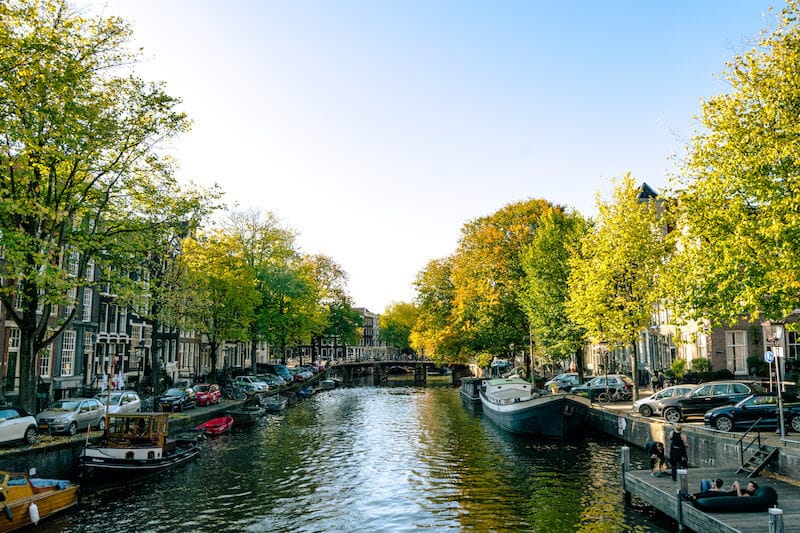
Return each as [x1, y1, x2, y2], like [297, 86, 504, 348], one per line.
[703, 394, 800, 432]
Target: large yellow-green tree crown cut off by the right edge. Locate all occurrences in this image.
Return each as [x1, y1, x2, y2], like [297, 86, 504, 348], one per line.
[665, 0, 800, 326]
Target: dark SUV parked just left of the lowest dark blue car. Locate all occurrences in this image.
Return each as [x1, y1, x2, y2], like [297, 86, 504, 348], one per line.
[661, 381, 763, 423]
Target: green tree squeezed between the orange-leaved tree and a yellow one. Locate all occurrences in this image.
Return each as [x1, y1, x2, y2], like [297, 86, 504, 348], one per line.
[520, 211, 590, 374]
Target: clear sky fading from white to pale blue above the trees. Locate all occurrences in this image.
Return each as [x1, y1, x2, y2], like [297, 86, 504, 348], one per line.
[84, 0, 782, 313]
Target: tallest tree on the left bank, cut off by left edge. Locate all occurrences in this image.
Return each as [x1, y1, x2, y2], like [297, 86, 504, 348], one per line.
[0, 0, 188, 410]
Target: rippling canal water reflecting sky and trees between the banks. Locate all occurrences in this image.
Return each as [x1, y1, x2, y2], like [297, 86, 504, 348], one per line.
[37, 385, 670, 533]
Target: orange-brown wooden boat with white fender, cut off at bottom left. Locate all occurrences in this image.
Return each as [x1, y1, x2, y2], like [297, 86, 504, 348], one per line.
[0, 470, 78, 531]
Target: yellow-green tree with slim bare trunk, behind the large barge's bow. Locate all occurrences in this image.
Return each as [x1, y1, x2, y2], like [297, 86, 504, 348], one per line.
[567, 174, 666, 398]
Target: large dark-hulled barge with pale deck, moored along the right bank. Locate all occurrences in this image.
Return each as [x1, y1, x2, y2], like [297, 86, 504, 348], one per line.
[480, 377, 591, 438]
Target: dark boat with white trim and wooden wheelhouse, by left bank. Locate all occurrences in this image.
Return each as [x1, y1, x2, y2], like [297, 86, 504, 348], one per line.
[79, 413, 200, 481]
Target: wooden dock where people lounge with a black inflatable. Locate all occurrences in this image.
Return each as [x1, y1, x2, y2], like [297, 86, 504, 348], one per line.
[623, 468, 800, 533]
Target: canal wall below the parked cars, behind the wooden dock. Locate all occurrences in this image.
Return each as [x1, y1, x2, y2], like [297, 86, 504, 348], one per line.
[589, 406, 800, 480]
